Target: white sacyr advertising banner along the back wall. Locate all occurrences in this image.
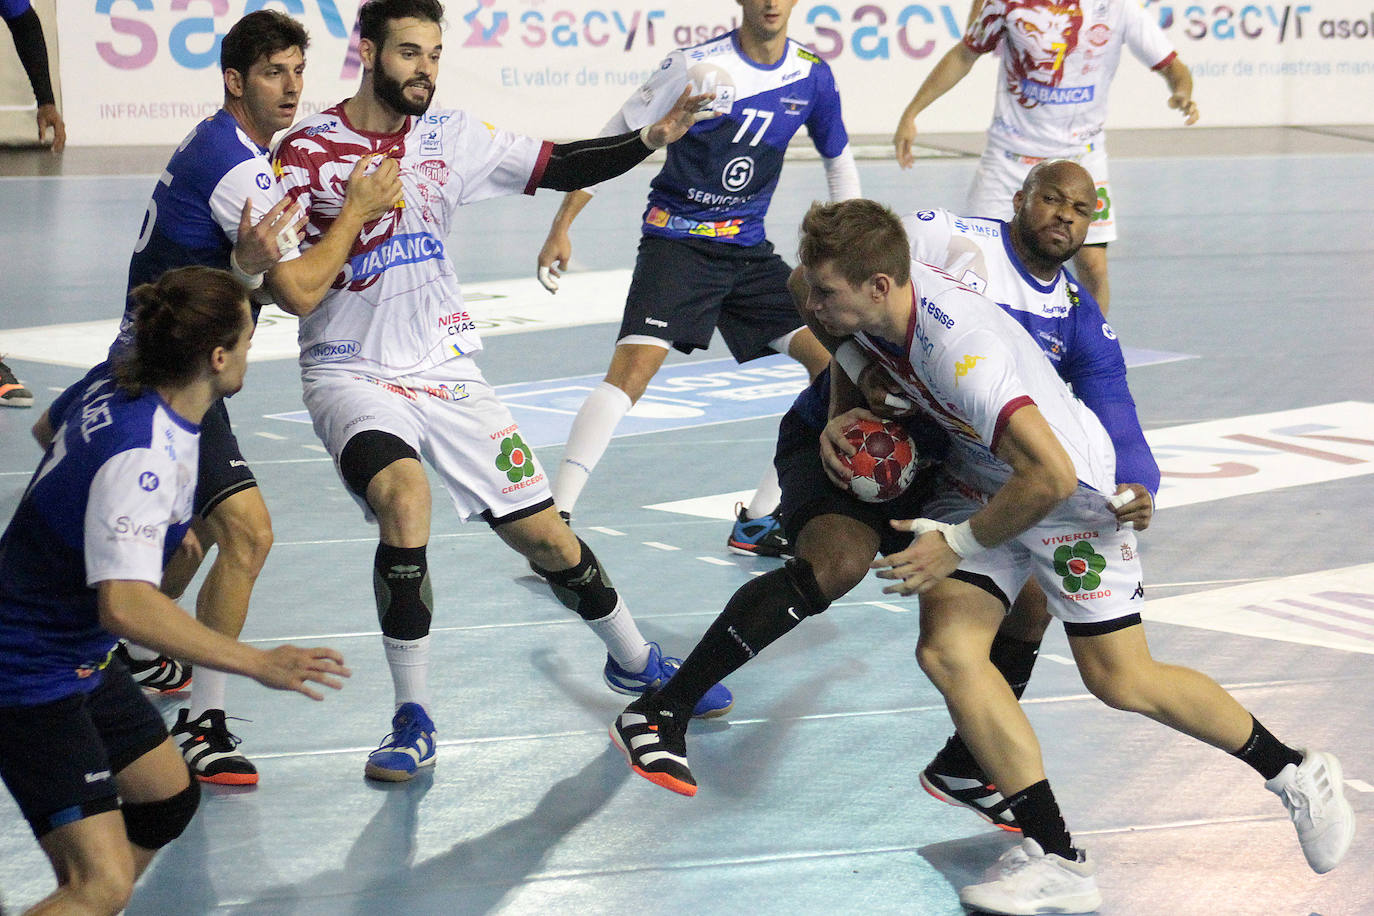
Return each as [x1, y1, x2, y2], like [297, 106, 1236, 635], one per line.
[58, 0, 1374, 144]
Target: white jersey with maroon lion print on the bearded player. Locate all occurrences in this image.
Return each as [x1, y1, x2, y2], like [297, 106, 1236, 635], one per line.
[276, 104, 552, 379]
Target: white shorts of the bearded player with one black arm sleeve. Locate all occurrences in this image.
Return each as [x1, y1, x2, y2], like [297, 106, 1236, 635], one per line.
[301, 357, 552, 522]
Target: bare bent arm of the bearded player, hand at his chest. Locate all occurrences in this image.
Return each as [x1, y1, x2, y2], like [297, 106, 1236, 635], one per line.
[267, 154, 403, 317]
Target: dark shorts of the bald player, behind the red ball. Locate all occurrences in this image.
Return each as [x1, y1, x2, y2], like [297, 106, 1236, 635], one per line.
[774, 411, 944, 556]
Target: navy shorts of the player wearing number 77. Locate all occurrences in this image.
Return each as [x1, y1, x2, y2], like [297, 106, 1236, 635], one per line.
[617, 235, 804, 363]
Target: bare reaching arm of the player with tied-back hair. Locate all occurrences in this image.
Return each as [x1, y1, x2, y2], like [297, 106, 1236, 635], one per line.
[96, 580, 352, 700]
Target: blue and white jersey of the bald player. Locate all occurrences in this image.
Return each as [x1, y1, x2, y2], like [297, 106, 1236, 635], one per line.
[901, 210, 1160, 493]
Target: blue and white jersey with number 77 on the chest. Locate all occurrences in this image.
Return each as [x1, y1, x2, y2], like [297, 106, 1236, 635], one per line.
[602, 32, 849, 246]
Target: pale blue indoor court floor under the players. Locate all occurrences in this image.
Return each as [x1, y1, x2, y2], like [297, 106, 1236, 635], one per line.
[0, 126, 1374, 916]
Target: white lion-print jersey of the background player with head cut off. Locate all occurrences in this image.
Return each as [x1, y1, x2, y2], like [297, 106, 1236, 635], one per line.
[963, 0, 1173, 157]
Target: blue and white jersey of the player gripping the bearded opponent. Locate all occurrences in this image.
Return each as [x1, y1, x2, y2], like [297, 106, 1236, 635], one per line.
[110, 108, 297, 356]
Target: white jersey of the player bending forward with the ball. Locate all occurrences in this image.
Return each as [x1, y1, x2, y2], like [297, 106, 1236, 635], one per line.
[855, 261, 1116, 496]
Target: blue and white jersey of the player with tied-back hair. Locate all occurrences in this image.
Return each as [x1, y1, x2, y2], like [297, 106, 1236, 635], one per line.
[0, 376, 201, 706]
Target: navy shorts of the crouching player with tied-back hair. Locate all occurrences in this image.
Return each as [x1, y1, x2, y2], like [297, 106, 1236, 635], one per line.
[0, 659, 168, 839]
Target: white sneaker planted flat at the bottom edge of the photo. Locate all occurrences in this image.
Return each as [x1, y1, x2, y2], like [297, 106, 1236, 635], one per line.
[959, 838, 1102, 916]
